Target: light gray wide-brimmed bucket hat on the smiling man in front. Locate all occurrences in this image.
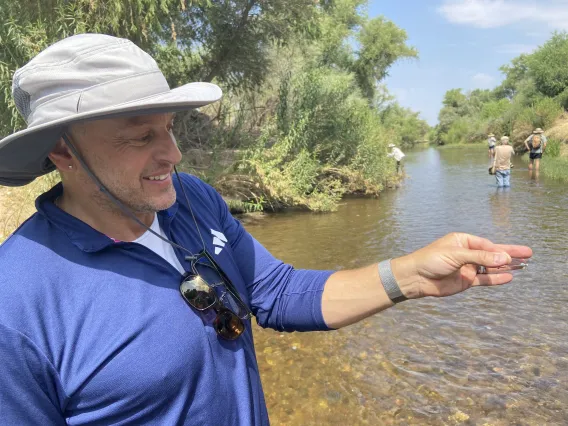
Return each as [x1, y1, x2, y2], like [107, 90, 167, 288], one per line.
[0, 34, 222, 186]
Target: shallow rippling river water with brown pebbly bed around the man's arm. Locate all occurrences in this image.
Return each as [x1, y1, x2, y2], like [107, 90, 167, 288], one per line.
[246, 149, 568, 426]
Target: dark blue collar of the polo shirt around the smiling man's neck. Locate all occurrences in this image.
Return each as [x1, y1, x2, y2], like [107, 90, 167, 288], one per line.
[35, 183, 178, 252]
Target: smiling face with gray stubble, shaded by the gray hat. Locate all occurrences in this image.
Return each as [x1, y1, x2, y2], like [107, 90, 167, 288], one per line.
[71, 114, 181, 213]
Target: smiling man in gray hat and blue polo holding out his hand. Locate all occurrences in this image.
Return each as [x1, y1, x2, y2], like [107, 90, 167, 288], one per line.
[0, 34, 532, 425]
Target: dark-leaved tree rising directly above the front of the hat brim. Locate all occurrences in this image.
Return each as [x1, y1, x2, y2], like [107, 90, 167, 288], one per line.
[175, 0, 318, 88]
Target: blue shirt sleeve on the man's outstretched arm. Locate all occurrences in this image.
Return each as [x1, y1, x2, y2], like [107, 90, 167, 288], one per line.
[195, 176, 334, 331]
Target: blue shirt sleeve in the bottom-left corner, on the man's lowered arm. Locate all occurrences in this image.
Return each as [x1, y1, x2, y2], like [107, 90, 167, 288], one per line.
[0, 324, 66, 425]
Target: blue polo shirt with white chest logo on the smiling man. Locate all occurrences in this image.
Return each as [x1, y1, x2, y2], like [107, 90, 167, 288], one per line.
[0, 174, 332, 426]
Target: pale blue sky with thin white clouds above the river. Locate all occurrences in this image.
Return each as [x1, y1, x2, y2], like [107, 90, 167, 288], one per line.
[367, 0, 568, 125]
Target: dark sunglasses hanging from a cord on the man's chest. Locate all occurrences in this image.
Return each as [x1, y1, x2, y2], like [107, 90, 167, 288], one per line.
[180, 250, 252, 340]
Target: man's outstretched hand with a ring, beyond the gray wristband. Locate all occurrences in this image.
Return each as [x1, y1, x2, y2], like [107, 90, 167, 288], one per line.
[391, 233, 532, 299]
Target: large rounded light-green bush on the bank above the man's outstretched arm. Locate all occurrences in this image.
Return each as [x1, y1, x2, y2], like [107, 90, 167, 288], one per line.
[240, 62, 394, 211]
